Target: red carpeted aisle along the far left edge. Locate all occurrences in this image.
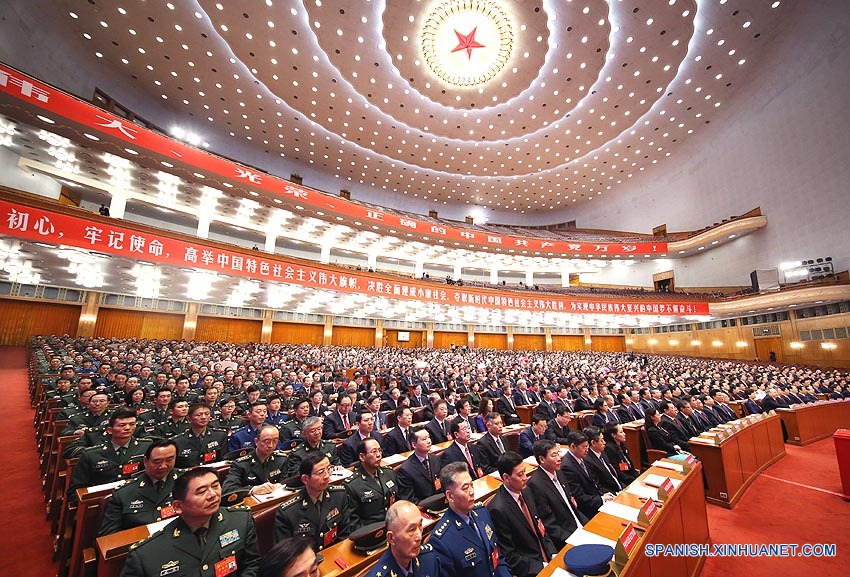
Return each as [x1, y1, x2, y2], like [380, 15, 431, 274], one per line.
[0, 347, 56, 577]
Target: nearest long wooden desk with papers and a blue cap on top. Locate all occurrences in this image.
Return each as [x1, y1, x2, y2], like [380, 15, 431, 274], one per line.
[538, 463, 709, 577]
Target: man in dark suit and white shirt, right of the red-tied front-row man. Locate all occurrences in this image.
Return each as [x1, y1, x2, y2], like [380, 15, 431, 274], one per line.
[528, 439, 587, 551]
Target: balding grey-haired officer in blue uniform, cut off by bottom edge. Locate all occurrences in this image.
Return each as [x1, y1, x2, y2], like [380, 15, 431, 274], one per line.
[366, 501, 450, 577]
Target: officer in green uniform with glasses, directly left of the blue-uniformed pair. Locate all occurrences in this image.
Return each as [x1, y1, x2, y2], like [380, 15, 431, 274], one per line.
[274, 450, 351, 551]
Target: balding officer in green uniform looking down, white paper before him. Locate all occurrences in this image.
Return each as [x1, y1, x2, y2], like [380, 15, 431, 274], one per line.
[223, 425, 286, 495]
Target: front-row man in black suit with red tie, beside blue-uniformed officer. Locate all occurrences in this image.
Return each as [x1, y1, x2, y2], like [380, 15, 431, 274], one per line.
[487, 452, 557, 577]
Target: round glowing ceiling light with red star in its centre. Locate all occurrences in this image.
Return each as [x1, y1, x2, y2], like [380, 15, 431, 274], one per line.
[420, 0, 514, 87]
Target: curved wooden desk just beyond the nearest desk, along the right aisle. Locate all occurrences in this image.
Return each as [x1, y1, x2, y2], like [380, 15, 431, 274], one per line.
[690, 415, 785, 509]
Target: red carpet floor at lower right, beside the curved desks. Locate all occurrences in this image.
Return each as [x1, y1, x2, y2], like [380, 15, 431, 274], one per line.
[702, 438, 850, 577]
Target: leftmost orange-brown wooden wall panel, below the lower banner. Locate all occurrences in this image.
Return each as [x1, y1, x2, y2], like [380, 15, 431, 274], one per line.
[0, 299, 81, 346]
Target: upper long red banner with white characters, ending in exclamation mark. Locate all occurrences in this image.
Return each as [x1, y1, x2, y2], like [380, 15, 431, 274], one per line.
[0, 64, 667, 257]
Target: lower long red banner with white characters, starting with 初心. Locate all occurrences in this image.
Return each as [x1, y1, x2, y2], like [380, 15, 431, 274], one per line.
[0, 200, 708, 315]
